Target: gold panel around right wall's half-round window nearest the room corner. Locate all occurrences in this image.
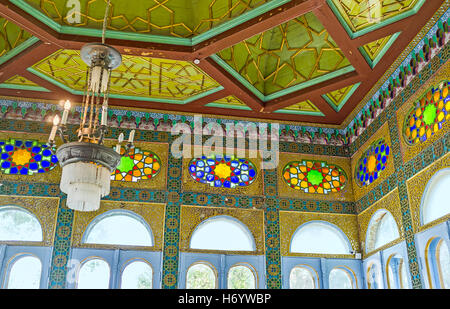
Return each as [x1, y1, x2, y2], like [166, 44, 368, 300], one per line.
[357, 188, 405, 255]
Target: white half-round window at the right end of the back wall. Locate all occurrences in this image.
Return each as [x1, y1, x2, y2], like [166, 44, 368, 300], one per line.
[290, 221, 351, 254]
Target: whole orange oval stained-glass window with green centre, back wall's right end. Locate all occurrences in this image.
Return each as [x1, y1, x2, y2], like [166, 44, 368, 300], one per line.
[283, 160, 347, 194]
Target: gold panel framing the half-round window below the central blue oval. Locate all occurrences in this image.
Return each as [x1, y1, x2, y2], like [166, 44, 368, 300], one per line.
[180, 205, 264, 255]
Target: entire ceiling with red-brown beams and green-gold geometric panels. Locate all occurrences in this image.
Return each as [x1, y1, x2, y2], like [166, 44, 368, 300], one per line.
[0, 0, 449, 128]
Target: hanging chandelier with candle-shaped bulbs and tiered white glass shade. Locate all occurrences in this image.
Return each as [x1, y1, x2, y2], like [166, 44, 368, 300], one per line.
[48, 1, 134, 211]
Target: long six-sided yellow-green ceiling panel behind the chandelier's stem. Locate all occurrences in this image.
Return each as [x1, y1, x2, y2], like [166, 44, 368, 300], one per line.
[29, 50, 223, 103]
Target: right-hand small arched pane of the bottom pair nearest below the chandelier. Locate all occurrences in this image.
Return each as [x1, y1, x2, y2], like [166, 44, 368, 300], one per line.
[120, 261, 153, 289]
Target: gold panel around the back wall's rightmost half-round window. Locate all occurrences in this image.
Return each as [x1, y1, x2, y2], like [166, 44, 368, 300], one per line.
[280, 211, 360, 258]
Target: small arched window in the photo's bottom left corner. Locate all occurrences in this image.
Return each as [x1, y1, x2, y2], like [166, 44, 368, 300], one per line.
[6, 255, 42, 289]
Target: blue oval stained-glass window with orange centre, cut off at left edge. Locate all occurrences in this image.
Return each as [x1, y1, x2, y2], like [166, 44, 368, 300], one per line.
[0, 139, 58, 175]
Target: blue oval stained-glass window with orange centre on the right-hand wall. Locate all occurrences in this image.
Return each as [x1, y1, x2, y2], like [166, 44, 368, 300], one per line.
[355, 139, 390, 187]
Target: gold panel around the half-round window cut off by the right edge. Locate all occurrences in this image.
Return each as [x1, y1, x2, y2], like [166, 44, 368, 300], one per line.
[406, 153, 450, 233]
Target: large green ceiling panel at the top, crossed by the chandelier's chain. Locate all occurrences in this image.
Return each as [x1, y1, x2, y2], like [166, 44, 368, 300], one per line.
[18, 0, 289, 41]
